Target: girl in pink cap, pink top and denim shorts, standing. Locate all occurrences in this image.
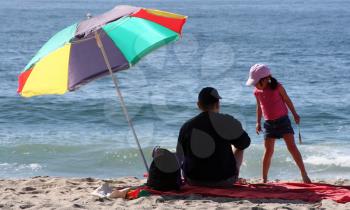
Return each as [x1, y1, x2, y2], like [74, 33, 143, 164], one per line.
[246, 64, 311, 183]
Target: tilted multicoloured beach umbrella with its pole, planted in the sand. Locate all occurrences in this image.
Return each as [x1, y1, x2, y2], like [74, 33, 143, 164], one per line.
[17, 5, 187, 170]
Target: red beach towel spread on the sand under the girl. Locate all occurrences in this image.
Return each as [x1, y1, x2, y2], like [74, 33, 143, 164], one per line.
[142, 183, 350, 203]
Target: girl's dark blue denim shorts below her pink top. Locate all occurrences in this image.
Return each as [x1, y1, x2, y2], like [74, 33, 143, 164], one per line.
[264, 115, 294, 139]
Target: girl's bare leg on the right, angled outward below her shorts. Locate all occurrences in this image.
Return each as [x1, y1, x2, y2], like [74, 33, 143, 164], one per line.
[283, 134, 311, 183]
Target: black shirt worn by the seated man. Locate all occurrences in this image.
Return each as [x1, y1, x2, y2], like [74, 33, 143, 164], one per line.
[177, 112, 250, 181]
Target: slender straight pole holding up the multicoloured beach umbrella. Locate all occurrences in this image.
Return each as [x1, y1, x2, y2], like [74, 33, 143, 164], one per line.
[95, 31, 148, 172]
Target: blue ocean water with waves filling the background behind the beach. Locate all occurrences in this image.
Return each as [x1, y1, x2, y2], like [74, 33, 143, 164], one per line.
[0, 0, 350, 179]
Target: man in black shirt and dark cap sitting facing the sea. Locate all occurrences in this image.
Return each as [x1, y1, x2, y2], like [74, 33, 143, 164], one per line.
[176, 87, 250, 187]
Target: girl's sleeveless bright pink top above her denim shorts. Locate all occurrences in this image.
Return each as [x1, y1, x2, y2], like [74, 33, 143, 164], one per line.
[254, 84, 288, 120]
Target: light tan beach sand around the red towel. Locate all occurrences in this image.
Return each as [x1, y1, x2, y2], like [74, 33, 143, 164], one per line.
[0, 177, 350, 210]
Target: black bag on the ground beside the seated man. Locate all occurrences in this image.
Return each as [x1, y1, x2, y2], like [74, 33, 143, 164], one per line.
[146, 147, 181, 191]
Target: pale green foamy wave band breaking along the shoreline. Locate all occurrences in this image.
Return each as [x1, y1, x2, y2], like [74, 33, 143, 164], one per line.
[0, 144, 350, 179]
